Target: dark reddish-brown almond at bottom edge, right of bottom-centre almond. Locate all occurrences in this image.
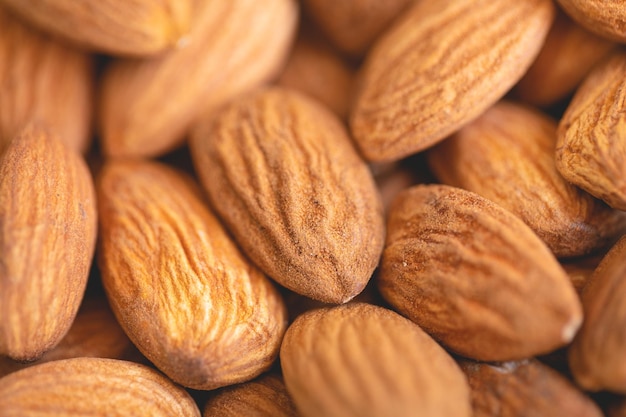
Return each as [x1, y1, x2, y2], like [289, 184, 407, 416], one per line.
[460, 359, 603, 417]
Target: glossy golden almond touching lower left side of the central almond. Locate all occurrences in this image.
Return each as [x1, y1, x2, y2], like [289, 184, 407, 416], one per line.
[98, 161, 286, 389]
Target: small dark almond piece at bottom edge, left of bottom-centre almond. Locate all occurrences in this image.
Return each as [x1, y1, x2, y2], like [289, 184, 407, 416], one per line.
[203, 375, 298, 417]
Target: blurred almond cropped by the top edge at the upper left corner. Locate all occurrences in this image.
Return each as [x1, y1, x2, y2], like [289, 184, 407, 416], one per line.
[0, 0, 193, 56]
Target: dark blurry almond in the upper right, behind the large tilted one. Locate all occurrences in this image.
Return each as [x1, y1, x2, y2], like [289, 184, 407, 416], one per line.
[514, 12, 616, 106]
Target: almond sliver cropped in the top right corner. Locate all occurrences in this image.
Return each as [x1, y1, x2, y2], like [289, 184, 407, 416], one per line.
[557, 0, 626, 43]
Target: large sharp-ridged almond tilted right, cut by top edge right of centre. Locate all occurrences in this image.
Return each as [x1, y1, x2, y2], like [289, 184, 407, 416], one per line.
[350, 0, 554, 161]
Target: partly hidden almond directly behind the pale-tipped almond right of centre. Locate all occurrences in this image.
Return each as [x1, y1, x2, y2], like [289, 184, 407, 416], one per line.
[428, 102, 626, 257]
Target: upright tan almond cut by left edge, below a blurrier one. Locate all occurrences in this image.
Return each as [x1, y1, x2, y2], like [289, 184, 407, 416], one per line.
[0, 126, 97, 361]
